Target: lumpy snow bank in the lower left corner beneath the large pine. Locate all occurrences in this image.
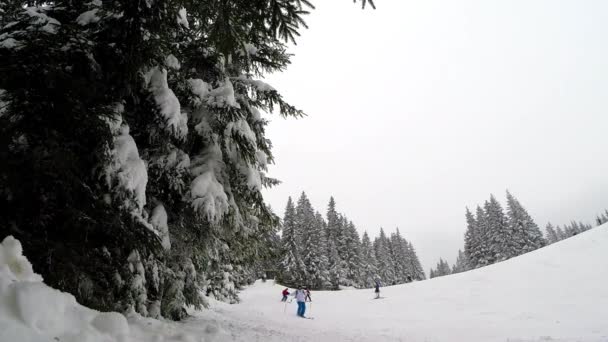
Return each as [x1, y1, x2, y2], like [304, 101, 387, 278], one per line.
[0, 236, 130, 342]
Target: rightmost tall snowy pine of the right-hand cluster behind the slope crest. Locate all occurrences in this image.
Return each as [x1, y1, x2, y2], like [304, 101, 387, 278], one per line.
[507, 191, 546, 258]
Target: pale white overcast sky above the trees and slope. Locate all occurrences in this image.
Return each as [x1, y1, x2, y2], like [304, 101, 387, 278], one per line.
[265, 0, 608, 275]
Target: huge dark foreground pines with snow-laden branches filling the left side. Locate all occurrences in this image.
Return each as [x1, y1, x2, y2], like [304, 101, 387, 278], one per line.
[0, 0, 372, 318]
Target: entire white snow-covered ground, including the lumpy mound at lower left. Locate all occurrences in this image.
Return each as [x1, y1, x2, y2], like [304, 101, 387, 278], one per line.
[0, 225, 608, 342]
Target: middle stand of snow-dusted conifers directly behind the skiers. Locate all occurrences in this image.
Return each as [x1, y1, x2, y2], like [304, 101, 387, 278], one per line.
[276, 193, 425, 289]
